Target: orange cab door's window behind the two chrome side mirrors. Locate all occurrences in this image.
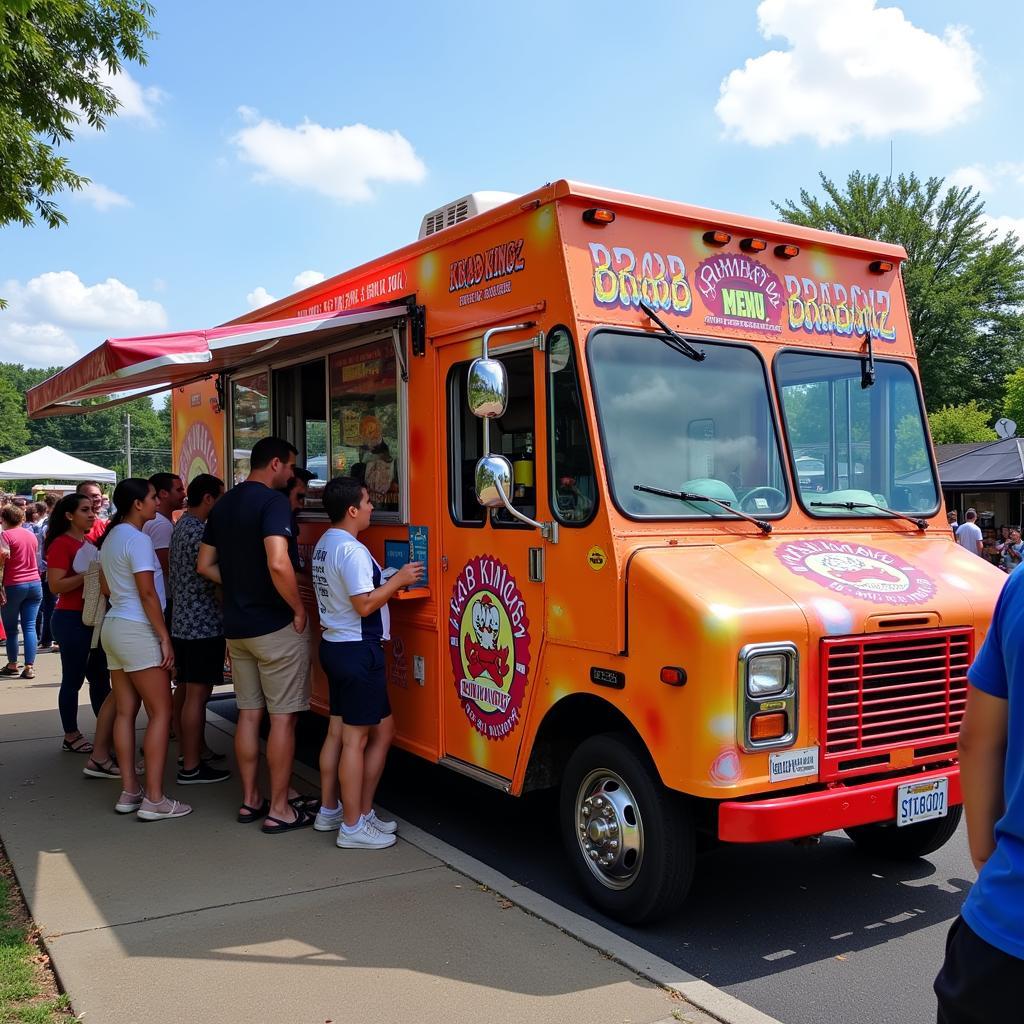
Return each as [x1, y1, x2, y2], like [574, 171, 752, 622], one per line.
[449, 349, 537, 529]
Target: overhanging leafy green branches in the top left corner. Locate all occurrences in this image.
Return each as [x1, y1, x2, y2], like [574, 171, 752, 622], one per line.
[0, 0, 155, 307]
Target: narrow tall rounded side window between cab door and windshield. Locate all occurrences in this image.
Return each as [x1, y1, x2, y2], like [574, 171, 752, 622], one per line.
[547, 327, 597, 526]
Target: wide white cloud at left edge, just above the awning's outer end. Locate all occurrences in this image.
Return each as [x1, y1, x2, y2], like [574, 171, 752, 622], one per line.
[0, 270, 167, 335]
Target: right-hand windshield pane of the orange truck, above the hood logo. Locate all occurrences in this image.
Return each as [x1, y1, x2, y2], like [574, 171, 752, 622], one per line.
[775, 351, 939, 517]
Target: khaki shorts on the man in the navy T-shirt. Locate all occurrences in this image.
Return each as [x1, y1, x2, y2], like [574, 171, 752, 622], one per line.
[227, 623, 310, 715]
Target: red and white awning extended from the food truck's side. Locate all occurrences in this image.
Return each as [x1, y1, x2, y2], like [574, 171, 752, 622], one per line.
[26, 304, 408, 419]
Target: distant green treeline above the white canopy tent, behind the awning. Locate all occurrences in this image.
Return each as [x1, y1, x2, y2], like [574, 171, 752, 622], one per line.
[0, 362, 171, 482]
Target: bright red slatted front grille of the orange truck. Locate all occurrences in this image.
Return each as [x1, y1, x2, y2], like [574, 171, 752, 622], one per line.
[820, 629, 974, 779]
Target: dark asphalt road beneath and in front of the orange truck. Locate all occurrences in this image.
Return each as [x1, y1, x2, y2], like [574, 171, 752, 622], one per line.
[209, 701, 974, 1024]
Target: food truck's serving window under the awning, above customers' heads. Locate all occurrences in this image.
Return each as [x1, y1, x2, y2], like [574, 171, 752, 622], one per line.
[230, 337, 408, 522]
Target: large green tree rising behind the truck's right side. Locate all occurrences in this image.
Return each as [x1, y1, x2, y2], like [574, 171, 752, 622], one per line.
[773, 171, 1024, 409]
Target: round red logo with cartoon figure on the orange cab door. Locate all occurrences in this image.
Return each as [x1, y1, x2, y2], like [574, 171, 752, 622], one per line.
[449, 555, 529, 739]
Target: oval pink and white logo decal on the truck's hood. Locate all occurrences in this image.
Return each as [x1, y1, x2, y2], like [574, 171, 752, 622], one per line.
[776, 541, 935, 604]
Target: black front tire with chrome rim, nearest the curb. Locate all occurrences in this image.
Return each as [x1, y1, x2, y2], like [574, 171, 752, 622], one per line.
[559, 733, 695, 925]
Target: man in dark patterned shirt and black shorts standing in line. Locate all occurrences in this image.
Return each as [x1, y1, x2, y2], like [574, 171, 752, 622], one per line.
[168, 473, 231, 785]
